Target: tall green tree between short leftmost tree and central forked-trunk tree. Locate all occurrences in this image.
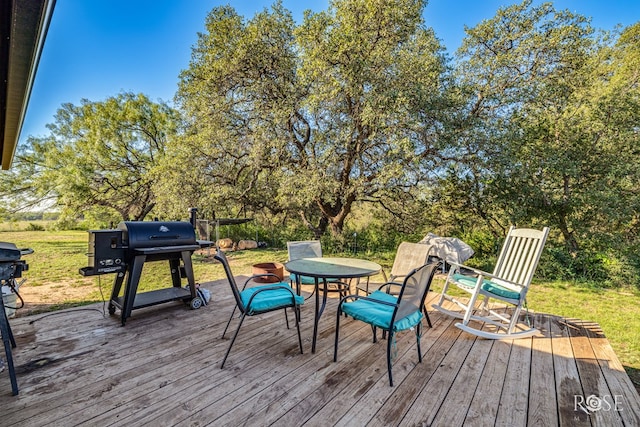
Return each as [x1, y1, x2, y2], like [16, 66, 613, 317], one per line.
[158, 5, 299, 224]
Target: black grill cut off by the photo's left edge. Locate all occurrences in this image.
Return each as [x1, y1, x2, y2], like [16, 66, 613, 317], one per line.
[0, 242, 33, 396]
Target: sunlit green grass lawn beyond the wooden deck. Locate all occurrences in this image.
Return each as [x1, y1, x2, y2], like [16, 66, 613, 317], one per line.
[0, 226, 640, 387]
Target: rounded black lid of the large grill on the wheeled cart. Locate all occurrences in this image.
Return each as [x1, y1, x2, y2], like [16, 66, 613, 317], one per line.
[118, 221, 197, 250]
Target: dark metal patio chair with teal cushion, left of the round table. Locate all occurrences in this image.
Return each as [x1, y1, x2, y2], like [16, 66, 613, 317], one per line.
[214, 249, 304, 369]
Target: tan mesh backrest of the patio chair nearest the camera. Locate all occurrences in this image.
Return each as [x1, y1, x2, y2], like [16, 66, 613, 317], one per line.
[393, 262, 440, 322]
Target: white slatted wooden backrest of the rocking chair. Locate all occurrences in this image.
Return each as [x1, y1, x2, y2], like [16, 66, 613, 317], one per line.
[493, 226, 549, 298]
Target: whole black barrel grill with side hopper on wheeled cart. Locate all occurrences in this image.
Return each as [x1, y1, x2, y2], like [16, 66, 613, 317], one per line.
[80, 221, 211, 326]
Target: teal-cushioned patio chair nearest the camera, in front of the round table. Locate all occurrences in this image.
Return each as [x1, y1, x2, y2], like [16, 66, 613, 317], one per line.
[333, 262, 440, 387]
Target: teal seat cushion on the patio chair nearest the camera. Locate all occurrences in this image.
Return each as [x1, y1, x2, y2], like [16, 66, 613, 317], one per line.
[342, 291, 423, 332]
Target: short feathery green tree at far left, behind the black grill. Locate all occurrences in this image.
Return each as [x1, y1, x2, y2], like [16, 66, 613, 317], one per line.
[2, 93, 179, 224]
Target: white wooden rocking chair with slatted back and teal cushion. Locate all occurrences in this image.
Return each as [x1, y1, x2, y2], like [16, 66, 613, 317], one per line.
[432, 227, 549, 339]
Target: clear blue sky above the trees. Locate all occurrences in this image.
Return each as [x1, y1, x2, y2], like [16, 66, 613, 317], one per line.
[20, 0, 640, 142]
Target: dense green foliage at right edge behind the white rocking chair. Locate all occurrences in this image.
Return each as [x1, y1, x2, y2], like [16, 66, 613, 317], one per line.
[444, 1, 640, 280]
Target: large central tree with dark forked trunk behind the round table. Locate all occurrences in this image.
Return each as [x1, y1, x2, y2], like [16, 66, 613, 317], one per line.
[290, 0, 446, 237]
